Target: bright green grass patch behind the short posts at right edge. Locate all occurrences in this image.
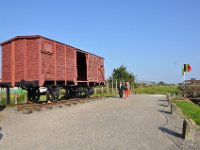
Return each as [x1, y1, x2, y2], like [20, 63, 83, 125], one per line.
[173, 101, 200, 125]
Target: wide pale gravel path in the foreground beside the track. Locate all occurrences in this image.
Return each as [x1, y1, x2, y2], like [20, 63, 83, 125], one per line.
[0, 95, 187, 150]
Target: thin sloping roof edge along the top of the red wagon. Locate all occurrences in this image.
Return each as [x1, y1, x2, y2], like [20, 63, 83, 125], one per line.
[0, 35, 104, 59]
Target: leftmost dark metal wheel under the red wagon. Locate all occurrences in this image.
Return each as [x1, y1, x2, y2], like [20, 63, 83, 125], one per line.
[28, 87, 40, 102]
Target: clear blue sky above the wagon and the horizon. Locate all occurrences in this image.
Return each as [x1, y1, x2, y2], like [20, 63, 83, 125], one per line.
[0, 0, 200, 83]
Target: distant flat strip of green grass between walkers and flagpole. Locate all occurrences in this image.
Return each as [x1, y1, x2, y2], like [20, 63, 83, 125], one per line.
[136, 86, 181, 94]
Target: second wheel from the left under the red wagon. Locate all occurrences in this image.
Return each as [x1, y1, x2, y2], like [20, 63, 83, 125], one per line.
[46, 88, 60, 102]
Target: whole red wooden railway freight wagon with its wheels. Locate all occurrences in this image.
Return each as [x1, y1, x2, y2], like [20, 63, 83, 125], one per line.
[1, 35, 105, 102]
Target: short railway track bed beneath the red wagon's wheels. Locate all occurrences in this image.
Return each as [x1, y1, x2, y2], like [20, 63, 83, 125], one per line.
[16, 97, 104, 113]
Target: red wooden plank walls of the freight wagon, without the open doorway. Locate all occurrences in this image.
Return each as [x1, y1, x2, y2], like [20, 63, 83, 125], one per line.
[1, 35, 105, 86]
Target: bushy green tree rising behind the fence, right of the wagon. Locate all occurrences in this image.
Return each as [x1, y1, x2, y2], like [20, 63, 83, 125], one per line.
[109, 65, 136, 82]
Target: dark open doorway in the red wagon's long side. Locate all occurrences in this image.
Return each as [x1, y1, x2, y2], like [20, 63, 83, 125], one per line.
[76, 51, 87, 81]
